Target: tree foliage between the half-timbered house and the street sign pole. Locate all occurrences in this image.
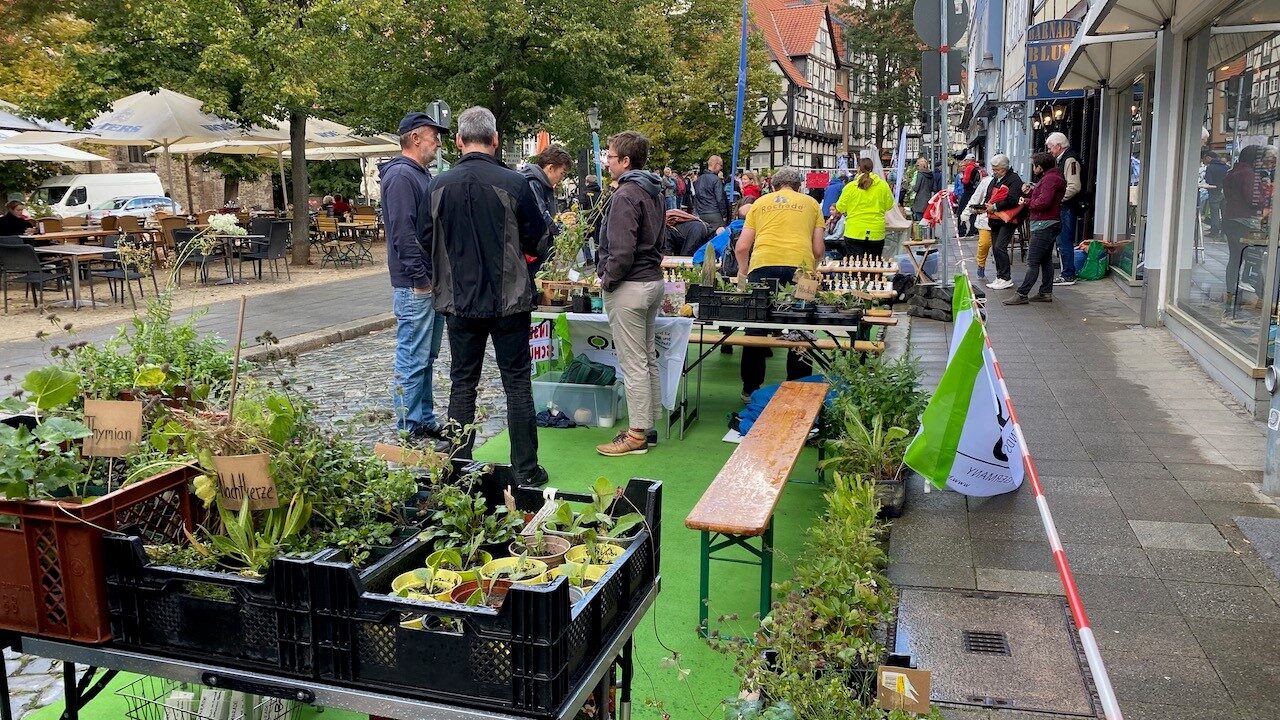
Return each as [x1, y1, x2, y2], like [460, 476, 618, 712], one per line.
[832, 0, 920, 147]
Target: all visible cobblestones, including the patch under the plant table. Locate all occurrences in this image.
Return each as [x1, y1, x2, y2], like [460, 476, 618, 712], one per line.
[5, 331, 507, 720]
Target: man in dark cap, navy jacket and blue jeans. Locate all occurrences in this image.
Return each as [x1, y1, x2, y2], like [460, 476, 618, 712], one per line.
[378, 113, 449, 441]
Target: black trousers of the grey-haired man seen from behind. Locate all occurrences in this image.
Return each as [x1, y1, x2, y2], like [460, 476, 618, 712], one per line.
[447, 313, 538, 480]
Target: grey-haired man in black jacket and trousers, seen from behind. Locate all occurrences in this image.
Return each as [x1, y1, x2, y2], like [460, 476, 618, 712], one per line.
[428, 106, 547, 484]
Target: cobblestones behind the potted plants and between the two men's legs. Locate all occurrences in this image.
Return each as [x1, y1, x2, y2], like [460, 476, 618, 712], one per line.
[256, 331, 507, 445]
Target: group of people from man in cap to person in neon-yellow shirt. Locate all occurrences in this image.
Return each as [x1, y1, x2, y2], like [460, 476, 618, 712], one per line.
[373, 106, 926, 471]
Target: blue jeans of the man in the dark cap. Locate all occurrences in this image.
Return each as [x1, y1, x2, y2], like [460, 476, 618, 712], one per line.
[392, 287, 444, 433]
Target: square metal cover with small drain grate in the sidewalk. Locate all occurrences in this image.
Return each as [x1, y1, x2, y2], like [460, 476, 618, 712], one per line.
[893, 587, 1098, 717]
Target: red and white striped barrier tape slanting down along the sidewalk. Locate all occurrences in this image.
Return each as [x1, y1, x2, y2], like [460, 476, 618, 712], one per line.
[942, 208, 1124, 720]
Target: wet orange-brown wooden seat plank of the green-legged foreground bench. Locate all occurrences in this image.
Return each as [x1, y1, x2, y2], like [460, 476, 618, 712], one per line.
[685, 382, 827, 537]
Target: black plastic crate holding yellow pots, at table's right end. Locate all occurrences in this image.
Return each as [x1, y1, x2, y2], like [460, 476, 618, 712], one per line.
[314, 478, 662, 717]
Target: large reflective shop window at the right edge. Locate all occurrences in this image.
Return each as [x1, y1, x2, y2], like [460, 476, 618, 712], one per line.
[1175, 29, 1276, 365]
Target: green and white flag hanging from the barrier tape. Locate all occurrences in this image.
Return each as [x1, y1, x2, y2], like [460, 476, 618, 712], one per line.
[906, 274, 1023, 497]
